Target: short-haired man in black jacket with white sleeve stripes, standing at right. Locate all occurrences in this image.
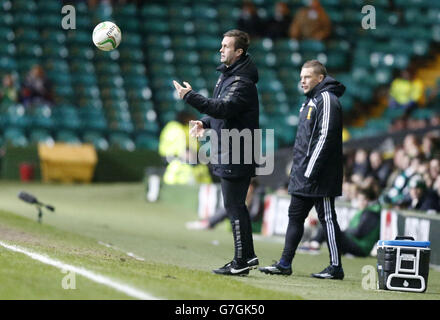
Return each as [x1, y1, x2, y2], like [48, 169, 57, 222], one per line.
[259, 60, 345, 279]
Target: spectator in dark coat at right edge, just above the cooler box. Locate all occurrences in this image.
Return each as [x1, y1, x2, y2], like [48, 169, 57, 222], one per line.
[404, 175, 440, 212]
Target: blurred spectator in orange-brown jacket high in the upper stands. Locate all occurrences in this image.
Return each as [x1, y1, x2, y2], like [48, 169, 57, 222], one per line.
[289, 0, 331, 41]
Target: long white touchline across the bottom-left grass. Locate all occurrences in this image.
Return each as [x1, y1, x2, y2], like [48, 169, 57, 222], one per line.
[0, 241, 159, 300]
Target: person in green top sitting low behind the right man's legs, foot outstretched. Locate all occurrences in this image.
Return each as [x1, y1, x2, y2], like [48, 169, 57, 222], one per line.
[299, 189, 382, 257]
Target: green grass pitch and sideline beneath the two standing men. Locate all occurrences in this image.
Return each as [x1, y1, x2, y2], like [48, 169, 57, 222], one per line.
[0, 182, 440, 300]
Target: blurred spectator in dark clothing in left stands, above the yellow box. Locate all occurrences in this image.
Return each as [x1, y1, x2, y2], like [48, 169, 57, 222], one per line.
[21, 65, 53, 106]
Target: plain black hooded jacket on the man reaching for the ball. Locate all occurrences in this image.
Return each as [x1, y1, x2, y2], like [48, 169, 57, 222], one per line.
[184, 54, 259, 178]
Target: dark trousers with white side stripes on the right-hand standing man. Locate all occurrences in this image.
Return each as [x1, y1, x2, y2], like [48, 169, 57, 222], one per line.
[282, 195, 341, 266]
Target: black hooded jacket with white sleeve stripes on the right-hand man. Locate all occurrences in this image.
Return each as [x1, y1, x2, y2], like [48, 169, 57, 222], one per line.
[288, 76, 345, 197]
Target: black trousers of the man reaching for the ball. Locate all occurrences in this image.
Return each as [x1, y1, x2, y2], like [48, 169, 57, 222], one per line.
[221, 177, 255, 264]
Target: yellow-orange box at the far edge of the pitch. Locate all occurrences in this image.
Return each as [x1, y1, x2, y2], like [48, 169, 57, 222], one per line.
[38, 143, 98, 183]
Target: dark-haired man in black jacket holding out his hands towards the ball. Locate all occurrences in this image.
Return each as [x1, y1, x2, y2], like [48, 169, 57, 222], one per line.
[174, 30, 259, 275]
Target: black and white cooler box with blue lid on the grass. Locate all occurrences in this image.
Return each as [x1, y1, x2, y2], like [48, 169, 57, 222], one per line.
[377, 237, 431, 292]
